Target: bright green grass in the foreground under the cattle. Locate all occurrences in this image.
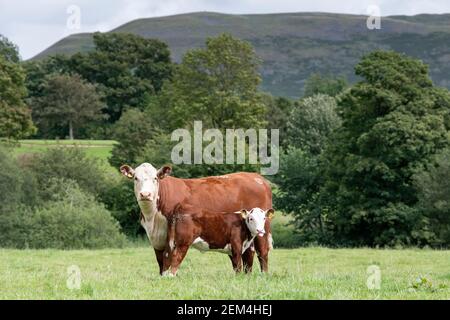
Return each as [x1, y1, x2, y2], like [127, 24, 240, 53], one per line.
[0, 247, 450, 299]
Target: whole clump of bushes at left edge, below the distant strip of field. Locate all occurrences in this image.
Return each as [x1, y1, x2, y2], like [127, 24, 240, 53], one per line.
[0, 147, 126, 249]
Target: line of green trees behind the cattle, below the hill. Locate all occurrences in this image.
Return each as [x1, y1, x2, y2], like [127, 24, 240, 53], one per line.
[0, 33, 450, 247]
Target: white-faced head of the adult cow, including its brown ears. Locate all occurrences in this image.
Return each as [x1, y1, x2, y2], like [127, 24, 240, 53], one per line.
[120, 163, 172, 203]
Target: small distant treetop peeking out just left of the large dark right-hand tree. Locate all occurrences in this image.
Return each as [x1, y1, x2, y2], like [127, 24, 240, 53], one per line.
[303, 73, 348, 98]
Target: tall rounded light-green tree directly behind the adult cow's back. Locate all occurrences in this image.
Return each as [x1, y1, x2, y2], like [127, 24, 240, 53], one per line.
[157, 34, 266, 129]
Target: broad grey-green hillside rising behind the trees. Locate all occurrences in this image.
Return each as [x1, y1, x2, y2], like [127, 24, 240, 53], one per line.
[35, 12, 450, 97]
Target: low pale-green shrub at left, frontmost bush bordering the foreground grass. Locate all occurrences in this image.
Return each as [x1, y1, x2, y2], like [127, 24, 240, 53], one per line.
[0, 181, 126, 249]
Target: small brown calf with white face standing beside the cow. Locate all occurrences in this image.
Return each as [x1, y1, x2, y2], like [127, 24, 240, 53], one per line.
[163, 205, 274, 275]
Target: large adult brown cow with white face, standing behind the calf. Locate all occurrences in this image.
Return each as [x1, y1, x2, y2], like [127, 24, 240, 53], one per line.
[120, 163, 272, 274]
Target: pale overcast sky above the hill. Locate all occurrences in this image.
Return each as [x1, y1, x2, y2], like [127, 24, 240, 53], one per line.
[0, 0, 450, 59]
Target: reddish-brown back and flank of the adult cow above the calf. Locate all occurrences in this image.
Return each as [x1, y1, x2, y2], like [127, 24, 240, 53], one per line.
[159, 172, 272, 214]
